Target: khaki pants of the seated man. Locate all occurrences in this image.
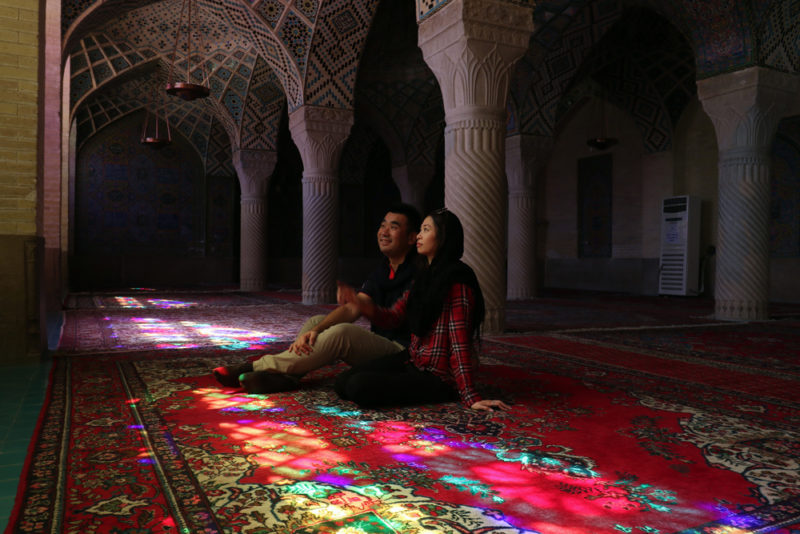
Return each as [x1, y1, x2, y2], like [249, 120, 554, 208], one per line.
[253, 315, 405, 376]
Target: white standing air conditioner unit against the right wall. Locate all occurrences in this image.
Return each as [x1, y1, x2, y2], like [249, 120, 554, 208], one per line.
[658, 196, 700, 295]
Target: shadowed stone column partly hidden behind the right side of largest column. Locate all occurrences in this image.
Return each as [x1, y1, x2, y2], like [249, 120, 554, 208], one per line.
[506, 135, 553, 300]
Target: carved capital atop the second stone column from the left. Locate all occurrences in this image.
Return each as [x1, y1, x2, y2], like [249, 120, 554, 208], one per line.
[289, 106, 353, 175]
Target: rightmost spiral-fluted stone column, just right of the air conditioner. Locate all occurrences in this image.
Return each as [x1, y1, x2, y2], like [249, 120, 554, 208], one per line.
[697, 67, 800, 321]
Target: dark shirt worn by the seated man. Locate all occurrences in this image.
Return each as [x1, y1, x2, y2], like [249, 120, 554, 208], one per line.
[359, 253, 417, 347]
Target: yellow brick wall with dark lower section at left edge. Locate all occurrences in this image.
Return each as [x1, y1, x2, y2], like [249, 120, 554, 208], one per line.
[0, 0, 43, 360]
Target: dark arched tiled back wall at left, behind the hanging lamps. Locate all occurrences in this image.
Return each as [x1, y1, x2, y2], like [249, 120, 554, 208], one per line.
[75, 114, 205, 256]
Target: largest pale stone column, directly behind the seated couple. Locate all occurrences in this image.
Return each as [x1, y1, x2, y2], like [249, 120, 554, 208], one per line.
[419, 0, 533, 333]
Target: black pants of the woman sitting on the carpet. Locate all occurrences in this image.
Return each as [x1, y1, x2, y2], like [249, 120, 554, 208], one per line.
[335, 351, 458, 408]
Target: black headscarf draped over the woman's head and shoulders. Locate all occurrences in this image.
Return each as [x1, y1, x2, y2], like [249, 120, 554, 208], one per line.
[407, 209, 486, 337]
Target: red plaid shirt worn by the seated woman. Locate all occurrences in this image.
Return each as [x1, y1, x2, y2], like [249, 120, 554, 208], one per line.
[372, 283, 481, 407]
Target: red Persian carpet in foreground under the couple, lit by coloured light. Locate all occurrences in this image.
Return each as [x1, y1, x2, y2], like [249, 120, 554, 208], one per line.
[6, 339, 800, 534]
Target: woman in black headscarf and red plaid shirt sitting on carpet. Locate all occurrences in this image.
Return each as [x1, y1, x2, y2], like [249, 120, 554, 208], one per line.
[336, 209, 510, 411]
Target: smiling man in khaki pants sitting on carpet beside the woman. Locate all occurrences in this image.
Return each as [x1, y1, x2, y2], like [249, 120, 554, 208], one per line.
[213, 204, 421, 393]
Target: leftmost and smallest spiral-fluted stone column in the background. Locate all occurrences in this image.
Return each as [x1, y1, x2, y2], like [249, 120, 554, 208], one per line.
[233, 149, 278, 291]
